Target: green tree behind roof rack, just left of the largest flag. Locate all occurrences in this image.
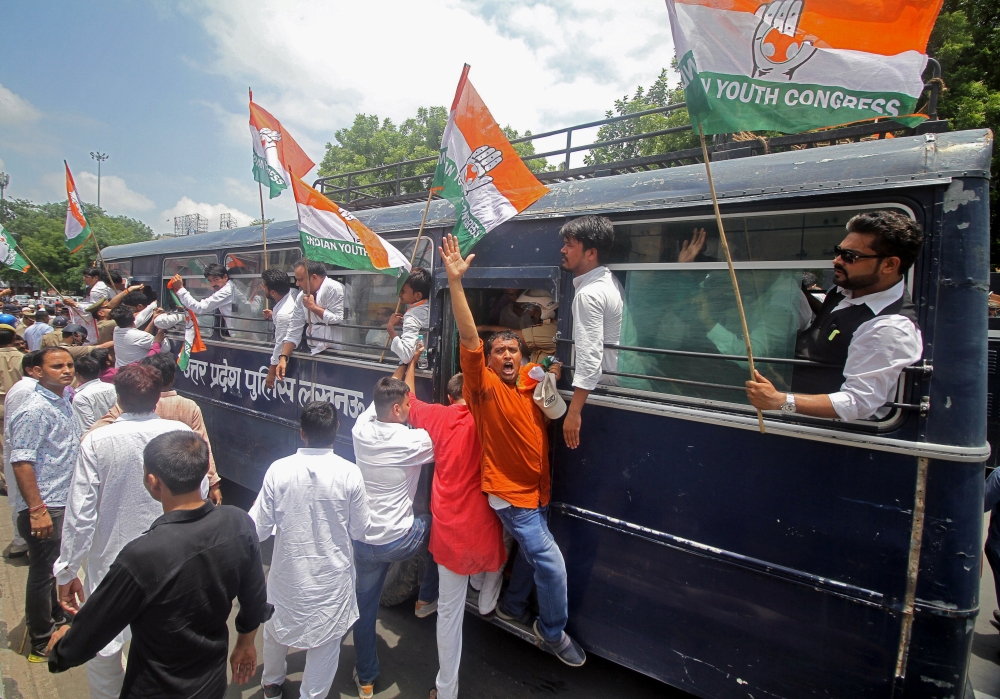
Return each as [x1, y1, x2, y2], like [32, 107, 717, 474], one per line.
[583, 67, 698, 165]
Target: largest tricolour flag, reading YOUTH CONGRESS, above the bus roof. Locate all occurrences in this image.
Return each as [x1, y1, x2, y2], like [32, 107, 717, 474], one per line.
[666, 0, 942, 134]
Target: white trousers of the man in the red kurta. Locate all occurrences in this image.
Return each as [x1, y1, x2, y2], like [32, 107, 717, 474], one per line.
[434, 565, 503, 699]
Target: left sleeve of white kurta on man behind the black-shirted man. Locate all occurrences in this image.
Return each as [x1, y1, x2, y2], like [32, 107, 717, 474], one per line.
[52, 439, 101, 585]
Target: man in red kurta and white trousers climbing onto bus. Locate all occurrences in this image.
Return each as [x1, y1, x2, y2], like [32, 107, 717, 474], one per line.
[394, 344, 507, 699]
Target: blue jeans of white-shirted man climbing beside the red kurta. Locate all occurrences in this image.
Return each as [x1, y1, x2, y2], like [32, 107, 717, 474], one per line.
[354, 515, 438, 684]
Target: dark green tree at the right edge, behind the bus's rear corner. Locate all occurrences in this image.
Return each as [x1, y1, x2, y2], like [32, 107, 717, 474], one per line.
[927, 0, 1000, 265]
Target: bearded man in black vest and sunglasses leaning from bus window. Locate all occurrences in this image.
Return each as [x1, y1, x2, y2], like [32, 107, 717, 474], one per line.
[746, 211, 924, 421]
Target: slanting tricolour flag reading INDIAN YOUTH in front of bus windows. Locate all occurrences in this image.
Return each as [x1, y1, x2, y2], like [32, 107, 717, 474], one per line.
[292, 176, 410, 279]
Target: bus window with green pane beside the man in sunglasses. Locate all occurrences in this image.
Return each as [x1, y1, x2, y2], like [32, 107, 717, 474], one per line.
[608, 206, 912, 412]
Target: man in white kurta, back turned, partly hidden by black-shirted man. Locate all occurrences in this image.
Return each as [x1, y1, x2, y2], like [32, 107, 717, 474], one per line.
[52, 365, 196, 699]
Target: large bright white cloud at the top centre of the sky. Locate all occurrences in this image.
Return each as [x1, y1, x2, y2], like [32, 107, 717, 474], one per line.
[185, 0, 673, 161]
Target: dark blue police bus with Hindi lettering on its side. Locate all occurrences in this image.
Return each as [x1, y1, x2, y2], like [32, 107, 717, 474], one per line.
[105, 131, 993, 699]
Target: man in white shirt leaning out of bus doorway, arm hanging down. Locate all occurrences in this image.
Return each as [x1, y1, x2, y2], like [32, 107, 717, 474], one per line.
[559, 216, 624, 449]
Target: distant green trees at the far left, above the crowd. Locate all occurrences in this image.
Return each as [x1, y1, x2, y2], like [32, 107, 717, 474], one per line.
[0, 199, 153, 294]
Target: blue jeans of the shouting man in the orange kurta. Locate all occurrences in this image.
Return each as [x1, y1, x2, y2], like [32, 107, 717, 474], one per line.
[496, 506, 569, 643]
